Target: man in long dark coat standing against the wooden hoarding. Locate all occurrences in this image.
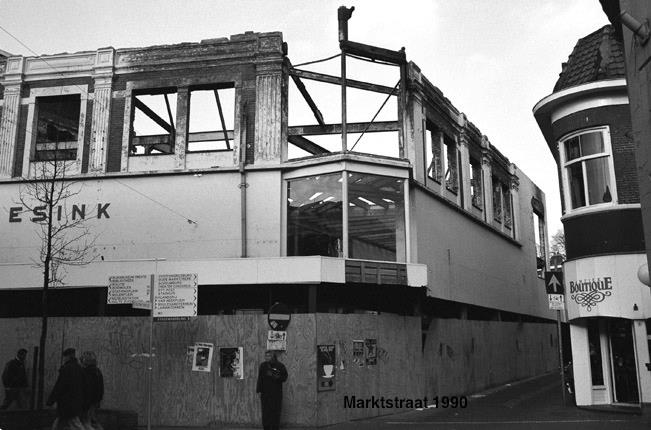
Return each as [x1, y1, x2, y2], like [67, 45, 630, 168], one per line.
[255, 351, 287, 430]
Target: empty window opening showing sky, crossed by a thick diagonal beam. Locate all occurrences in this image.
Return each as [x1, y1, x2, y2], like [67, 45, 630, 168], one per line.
[130, 89, 176, 155]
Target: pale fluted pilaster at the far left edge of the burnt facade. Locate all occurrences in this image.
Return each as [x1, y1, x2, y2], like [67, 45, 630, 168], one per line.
[0, 57, 24, 178]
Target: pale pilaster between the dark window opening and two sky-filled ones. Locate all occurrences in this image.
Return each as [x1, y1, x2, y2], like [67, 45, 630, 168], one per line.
[88, 48, 115, 173]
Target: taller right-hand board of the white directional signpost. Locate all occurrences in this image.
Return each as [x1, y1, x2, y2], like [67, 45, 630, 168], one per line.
[154, 273, 199, 318]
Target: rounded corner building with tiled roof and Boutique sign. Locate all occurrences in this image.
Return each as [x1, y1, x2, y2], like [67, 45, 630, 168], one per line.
[533, 25, 651, 406]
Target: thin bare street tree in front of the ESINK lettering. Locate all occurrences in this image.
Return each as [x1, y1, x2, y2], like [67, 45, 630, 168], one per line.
[19, 154, 96, 409]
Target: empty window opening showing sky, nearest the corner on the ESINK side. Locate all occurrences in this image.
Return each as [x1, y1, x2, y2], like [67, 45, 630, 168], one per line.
[187, 87, 235, 152]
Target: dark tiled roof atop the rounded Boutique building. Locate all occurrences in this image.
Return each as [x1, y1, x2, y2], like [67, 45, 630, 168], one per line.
[554, 25, 626, 92]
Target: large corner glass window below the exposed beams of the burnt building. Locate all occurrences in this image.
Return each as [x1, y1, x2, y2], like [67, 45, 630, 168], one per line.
[287, 172, 406, 262]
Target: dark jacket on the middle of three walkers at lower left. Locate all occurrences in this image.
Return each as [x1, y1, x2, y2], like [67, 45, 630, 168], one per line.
[47, 358, 84, 418]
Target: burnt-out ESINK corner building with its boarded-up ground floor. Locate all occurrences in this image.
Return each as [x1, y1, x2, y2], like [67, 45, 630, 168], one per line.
[0, 27, 557, 425]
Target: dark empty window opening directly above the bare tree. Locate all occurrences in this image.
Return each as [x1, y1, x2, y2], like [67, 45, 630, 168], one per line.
[34, 94, 81, 161]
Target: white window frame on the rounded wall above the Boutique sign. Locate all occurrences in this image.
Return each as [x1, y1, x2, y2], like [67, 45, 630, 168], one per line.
[558, 125, 618, 215]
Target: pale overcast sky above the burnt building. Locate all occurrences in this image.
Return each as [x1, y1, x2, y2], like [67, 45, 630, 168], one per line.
[0, 0, 608, 236]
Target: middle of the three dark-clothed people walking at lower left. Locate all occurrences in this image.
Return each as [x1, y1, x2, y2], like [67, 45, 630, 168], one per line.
[47, 348, 85, 430]
